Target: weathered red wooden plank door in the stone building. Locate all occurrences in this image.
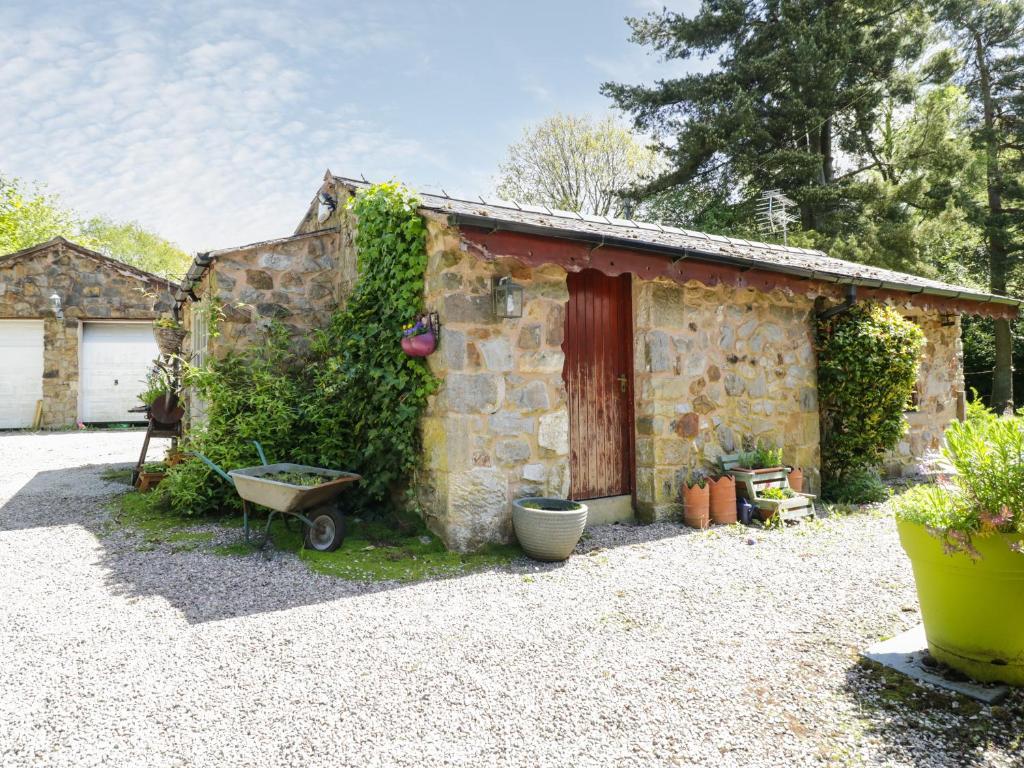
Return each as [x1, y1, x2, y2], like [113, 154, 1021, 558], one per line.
[564, 269, 633, 499]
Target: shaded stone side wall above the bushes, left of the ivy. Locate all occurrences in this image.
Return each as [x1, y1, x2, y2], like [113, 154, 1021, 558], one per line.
[184, 228, 356, 356]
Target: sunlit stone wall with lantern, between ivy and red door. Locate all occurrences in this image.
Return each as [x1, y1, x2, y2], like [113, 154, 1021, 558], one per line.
[419, 221, 569, 551]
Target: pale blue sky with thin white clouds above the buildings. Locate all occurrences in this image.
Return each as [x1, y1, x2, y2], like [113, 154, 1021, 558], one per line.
[0, 0, 696, 256]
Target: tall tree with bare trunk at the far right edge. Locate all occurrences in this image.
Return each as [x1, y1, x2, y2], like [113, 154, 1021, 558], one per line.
[936, 0, 1024, 412]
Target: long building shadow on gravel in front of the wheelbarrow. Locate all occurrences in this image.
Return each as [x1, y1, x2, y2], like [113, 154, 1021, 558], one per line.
[0, 464, 695, 624]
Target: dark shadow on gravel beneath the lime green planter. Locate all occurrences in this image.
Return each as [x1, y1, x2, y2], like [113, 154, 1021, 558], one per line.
[844, 658, 1024, 767]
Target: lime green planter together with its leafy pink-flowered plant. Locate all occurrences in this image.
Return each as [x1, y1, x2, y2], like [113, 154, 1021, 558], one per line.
[893, 416, 1024, 685]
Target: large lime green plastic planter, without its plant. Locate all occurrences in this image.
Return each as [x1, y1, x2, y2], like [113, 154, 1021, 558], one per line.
[896, 520, 1024, 686]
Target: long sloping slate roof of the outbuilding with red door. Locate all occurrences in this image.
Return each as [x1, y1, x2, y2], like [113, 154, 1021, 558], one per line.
[333, 176, 1024, 306]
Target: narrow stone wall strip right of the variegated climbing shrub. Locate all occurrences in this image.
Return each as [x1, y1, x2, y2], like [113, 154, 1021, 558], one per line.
[885, 308, 965, 476]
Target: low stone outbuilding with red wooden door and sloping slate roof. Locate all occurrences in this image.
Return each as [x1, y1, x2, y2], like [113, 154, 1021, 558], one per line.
[178, 172, 1019, 550]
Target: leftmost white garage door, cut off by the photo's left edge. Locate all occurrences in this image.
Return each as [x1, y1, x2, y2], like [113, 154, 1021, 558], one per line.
[0, 321, 43, 429]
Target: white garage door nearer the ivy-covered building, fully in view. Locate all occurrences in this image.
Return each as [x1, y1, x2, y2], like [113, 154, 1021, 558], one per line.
[78, 323, 160, 422]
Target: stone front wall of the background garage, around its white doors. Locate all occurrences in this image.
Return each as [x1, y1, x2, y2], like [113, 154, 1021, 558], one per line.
[0, 241, 173, 427]
